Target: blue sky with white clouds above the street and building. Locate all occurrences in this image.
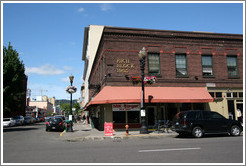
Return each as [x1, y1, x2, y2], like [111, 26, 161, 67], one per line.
[1, 1, 244, 100]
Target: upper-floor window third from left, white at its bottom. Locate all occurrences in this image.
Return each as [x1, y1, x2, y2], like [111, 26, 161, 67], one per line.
[202, 55, 214, 77]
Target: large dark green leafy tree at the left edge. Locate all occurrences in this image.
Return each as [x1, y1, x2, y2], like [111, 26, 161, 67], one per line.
[3, 43, 26, 114]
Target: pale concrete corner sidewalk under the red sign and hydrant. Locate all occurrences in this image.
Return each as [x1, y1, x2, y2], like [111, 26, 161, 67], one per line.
[59, 123, 178, 142]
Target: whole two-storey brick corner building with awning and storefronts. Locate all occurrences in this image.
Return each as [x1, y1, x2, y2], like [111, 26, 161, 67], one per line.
[82, 25, 243, 129]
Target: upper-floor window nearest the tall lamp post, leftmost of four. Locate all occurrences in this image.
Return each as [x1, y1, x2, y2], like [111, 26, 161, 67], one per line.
[148, 53, 161, 75]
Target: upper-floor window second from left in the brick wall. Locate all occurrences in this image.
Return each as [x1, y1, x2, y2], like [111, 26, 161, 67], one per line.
[175, 55, 188, 77]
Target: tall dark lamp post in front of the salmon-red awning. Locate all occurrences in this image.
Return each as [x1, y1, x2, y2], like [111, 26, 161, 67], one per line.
[138, 47, 148, 134]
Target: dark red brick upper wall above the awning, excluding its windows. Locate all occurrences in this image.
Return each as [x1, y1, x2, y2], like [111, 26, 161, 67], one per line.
[90, 28, 243, 100]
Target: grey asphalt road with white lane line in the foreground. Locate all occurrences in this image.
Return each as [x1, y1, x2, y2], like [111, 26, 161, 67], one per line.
[3, 123, 243, 163]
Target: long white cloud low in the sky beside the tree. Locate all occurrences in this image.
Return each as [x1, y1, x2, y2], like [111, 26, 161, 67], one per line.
[25, 64, 65, 75]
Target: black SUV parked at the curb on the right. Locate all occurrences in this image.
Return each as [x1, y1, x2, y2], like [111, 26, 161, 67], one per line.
[172, 110, 243, 138]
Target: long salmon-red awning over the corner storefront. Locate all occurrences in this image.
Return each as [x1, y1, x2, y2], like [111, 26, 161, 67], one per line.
[87, 86, 213, 106]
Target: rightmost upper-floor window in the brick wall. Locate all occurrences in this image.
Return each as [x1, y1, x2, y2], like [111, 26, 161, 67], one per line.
[227, 56, 238, 78]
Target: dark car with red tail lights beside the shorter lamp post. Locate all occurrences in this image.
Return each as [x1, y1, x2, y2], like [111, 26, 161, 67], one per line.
[46, 117, 65, 131]
